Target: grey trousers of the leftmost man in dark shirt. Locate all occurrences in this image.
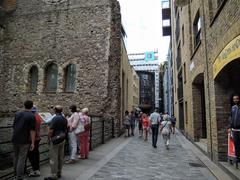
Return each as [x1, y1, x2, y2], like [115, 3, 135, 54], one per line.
[13, 144, 29, 179]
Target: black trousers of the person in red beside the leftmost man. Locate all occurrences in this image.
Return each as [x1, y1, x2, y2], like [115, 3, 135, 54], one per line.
[28, 140, 40, 171]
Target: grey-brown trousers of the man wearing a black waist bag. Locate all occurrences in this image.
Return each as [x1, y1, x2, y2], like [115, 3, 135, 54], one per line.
[49, 141, 65, 178]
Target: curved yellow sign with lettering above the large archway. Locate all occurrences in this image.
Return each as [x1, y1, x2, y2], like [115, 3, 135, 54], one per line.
[213, 35, 240, 79]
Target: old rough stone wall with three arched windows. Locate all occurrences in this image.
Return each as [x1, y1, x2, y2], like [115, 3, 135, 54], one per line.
[0, 0, 121, 129]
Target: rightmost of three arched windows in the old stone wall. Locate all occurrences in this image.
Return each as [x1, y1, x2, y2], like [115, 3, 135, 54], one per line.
[65, 64, 76, 92]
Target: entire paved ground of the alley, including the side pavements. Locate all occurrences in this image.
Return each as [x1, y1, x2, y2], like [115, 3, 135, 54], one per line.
[30, 132, 231, 180]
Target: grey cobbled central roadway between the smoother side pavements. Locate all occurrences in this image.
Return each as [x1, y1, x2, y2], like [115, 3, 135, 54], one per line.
[91, 131, 216, 180]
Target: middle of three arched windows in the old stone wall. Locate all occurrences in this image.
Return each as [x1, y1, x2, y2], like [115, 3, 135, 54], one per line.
[45, 64, 58, 92]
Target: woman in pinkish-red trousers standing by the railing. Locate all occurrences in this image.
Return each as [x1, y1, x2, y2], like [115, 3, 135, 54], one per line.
[78, 108, 91, 159]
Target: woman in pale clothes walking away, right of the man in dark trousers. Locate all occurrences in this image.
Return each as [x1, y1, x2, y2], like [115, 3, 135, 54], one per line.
[160, 114, 172, 149]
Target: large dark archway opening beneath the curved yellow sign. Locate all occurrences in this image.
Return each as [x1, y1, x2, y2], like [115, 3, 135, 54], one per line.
[214, 59, 240, 160]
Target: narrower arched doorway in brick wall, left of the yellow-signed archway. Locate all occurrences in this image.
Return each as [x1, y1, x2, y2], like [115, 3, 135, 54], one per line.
[192, 73, 207, 141]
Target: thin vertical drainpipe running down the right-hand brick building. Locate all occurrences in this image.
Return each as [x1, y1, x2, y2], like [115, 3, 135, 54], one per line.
[201, 0, 213, 160]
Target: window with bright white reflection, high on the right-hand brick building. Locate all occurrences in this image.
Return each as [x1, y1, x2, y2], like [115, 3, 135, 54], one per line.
[193, 11, 202, 48]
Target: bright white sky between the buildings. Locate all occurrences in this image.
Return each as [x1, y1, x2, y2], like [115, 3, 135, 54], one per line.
[118, 0, 170, 62]
